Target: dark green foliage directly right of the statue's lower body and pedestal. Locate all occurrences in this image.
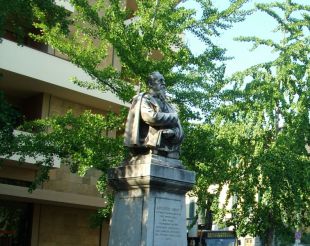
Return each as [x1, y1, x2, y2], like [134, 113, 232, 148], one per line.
[181, 125, 232, 228]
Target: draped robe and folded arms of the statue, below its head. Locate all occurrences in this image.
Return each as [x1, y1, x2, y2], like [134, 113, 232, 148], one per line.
[124, 93, 184, 152]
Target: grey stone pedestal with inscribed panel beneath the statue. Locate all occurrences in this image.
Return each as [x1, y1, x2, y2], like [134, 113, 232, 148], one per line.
[108, 155, 195, 246]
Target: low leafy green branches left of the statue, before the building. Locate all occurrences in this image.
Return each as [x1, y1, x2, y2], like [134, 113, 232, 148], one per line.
[15, 111, 125, 192]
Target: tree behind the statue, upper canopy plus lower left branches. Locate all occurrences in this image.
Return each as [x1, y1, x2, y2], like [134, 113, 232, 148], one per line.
[1, 0, 251, 219]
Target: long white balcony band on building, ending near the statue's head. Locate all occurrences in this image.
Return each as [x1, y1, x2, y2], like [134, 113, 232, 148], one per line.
[0, 39, 128, 112]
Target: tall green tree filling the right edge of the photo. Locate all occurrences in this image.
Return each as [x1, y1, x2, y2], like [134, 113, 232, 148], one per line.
[206, 0, 310, 245]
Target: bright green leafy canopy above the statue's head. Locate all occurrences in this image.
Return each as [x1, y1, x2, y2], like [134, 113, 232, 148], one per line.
[27, 0, 247, 118]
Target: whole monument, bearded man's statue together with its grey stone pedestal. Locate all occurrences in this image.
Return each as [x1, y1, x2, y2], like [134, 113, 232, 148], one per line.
[108, 72, 195, 246]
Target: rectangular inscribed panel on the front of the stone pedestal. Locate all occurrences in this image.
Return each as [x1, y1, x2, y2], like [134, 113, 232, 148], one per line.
[153, 198, 184, 246]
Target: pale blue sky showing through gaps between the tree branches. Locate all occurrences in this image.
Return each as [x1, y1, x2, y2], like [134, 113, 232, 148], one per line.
[185, 0, 309, 76]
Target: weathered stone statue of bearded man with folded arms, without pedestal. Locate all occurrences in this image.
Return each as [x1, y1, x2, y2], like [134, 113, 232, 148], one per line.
[125, 72, 184, 159]
